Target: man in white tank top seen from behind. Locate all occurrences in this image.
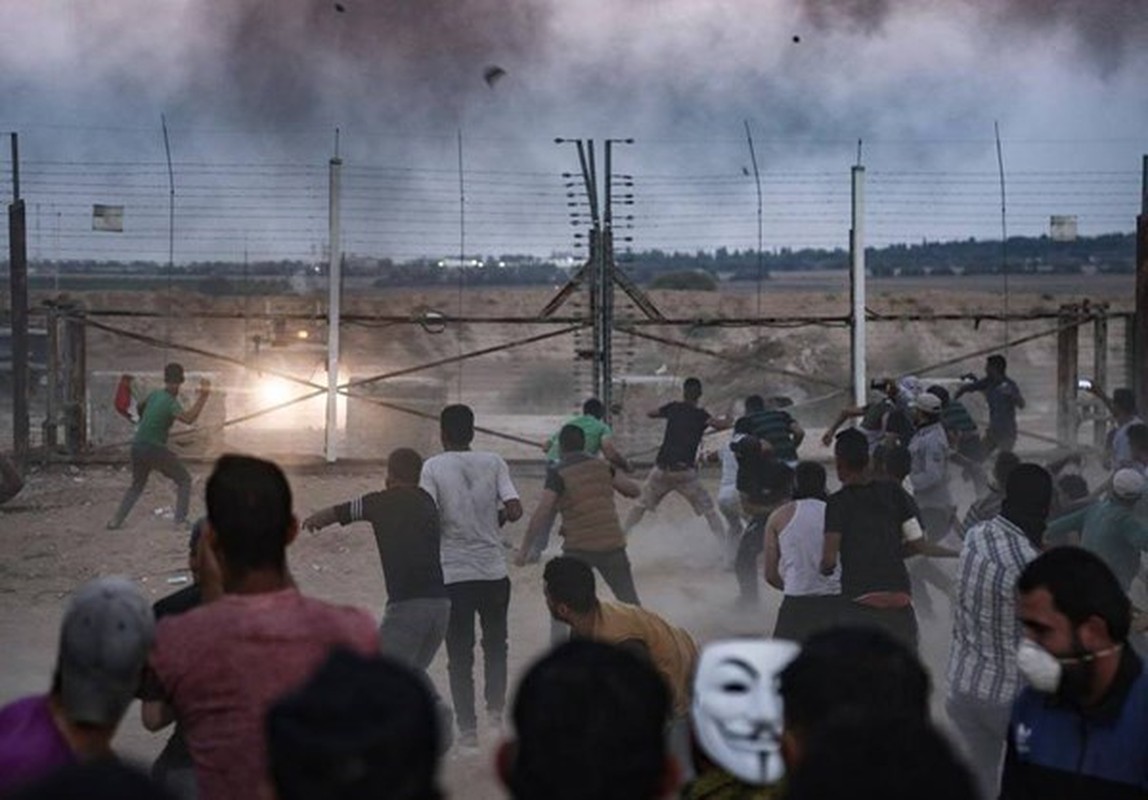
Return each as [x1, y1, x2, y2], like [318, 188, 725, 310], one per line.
[766, 461, 841, 642]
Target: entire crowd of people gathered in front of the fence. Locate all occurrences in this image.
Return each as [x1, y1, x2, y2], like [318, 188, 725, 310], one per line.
[0, 356, 1148, 800]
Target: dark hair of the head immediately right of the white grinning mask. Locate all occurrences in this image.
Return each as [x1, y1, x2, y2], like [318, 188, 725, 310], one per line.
[778, 627, 930, 736]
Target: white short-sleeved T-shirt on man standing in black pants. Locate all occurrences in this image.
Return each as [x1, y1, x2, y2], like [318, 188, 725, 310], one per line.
[419, 450, 518, 583]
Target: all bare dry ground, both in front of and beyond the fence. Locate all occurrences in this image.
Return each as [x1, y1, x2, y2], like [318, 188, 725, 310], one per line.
[0, 272, 1131, 798]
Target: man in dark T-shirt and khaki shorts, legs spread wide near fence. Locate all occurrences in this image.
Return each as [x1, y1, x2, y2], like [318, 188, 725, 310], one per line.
[625, 378, 729, 542]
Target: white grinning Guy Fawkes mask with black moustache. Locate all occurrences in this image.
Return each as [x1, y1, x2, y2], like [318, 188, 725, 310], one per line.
[690, 639, 800, 786]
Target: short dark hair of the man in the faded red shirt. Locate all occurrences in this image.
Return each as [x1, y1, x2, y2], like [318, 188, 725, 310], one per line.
[204, 455, 294, 575]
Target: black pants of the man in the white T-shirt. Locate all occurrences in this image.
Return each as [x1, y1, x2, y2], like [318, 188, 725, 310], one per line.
[447, 577, 510, 732]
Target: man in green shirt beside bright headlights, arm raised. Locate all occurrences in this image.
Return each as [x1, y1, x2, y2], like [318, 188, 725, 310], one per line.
[108, 363, 211, 530]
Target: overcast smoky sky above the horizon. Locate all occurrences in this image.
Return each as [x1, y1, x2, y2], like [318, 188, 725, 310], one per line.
[0, 0, 1148, 261]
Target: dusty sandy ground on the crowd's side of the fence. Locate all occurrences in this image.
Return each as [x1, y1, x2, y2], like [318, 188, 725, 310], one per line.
[0, 452, 978, 800]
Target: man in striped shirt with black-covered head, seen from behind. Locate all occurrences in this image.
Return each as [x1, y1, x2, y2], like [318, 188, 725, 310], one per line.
[945, 464, 1053, 798]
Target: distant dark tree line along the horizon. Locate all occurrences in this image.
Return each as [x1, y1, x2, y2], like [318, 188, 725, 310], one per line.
[13, 233, 1135, 295]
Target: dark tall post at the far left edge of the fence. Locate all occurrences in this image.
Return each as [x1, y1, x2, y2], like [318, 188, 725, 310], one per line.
[8, 133, 30, 464]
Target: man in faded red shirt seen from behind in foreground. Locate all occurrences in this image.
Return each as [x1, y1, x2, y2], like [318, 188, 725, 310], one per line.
[142, 456, 379, 800]
